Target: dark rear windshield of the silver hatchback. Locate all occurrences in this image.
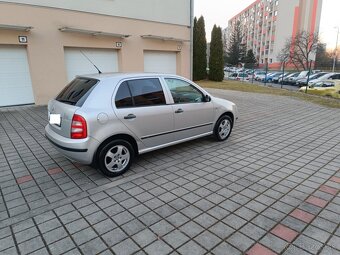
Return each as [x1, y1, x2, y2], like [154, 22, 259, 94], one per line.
[56, 78, 98, 106]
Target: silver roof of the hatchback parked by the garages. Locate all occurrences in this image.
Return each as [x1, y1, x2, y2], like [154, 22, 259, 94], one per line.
[76, 73, 182, 80]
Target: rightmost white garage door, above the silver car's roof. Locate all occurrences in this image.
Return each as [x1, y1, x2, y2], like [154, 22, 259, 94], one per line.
[144, 51, 177, 74]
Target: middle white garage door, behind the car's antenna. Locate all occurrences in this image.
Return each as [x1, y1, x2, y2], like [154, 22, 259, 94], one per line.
[65, 48, 118, 81]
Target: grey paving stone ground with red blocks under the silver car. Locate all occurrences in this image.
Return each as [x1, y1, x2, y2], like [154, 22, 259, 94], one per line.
[0, 90, 340, 255]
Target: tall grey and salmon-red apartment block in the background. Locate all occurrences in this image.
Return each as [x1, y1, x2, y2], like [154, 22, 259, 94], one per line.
[228, 0, 323, 69]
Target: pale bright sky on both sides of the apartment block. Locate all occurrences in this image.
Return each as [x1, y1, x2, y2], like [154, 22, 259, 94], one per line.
[194, 0, 340, 49]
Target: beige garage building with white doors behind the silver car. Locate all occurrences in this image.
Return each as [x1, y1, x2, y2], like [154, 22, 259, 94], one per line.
[0, 0, 193, 106]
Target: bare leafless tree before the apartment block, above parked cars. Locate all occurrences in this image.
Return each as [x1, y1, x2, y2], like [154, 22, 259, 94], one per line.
[278, 31, 320, 70]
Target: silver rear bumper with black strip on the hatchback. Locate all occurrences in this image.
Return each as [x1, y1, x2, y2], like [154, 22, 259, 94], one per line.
[45, 124, 99, 164]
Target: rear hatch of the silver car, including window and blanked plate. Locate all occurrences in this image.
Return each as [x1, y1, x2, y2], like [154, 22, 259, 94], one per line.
[48, 77, 98, 138]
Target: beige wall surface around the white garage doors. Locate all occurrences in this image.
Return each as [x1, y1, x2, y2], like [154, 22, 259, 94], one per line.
[0, 2, 190, 104]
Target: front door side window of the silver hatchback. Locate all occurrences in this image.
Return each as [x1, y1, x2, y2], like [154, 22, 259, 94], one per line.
[165, 78, 204, 104]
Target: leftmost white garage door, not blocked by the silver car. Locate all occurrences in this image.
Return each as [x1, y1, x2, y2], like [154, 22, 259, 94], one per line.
[0, 46, 34, 106]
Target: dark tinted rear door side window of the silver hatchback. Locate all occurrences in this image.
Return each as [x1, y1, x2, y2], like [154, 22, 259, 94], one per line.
[115, 78, 166, 108]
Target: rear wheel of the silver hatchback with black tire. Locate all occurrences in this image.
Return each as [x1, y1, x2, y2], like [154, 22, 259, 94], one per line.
[97, 139, 135, 177]
